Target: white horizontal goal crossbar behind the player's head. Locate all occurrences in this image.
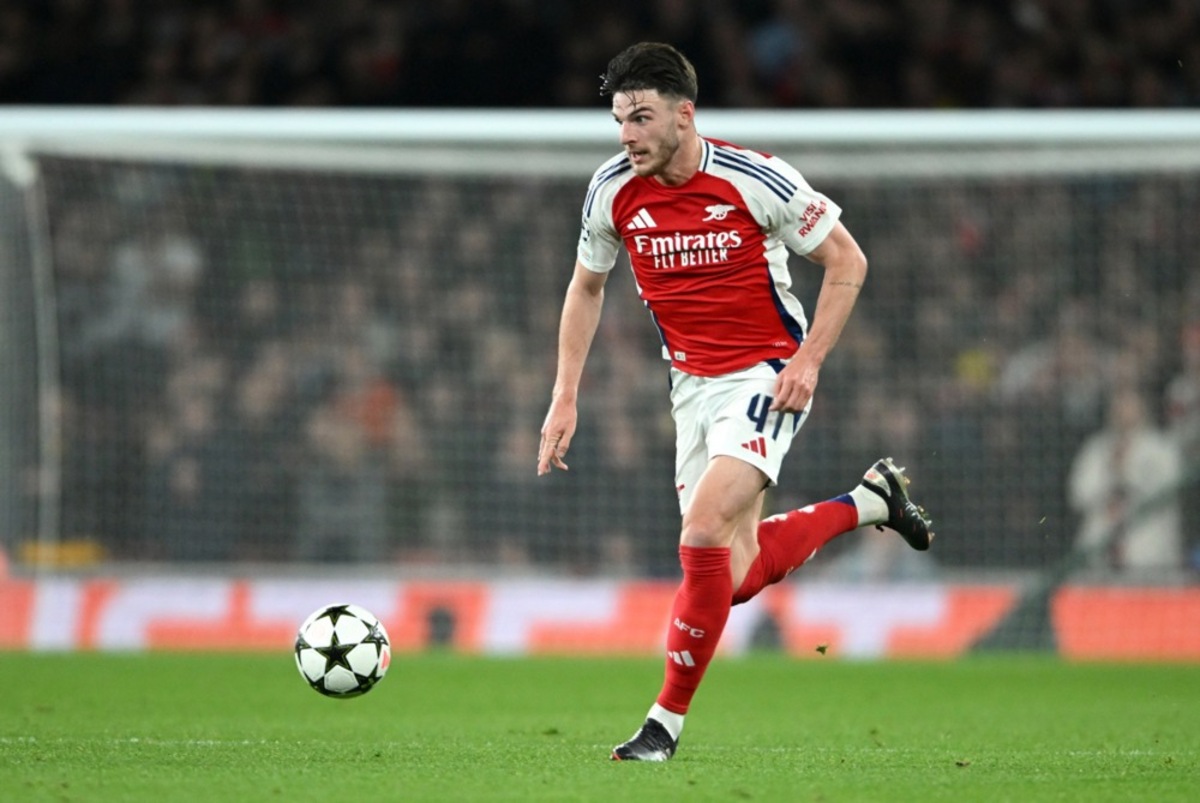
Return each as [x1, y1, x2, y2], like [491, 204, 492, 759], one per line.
[7, 107, 1200, 178]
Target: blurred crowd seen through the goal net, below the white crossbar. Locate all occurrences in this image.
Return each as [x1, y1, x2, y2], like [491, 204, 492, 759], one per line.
[14, 151, 1200, 576]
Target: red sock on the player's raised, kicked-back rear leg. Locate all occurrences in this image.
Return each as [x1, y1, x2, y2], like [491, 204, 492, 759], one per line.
[733, 496, 858, 605]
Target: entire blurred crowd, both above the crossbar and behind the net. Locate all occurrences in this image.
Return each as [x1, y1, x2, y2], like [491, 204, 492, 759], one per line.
[0, 0, 1200, 576]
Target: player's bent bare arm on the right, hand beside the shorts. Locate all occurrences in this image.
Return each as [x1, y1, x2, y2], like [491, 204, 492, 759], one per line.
[772, 222, 866, 413]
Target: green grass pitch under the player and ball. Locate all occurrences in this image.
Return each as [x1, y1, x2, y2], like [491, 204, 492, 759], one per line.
[0, 653, 1200, 803]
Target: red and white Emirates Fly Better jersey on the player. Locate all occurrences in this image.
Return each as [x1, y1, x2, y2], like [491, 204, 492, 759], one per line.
[578, 139, 841, 377]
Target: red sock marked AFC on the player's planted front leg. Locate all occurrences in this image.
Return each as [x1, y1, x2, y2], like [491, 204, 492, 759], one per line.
[658, 546, 733, 714]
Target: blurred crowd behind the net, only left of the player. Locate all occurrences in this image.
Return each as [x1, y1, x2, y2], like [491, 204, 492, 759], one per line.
[30, 160, 677, 568]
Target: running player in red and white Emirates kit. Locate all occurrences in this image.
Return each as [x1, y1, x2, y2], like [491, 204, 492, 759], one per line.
[538, 42, 932, 761]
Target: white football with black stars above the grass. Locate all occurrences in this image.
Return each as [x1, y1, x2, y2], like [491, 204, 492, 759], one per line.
[295, 603, 391, 697]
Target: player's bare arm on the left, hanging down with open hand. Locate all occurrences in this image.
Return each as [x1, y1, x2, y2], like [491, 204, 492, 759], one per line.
[538, 262, 608, 477]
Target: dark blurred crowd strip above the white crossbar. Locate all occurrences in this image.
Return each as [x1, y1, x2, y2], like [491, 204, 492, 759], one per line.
[0, 0, 1200, 108]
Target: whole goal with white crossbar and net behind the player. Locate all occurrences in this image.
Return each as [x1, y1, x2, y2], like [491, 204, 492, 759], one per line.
[0, 110, 1200, 595]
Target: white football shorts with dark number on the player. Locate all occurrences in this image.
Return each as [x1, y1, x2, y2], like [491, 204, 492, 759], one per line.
[671, 362, 812, 514]
